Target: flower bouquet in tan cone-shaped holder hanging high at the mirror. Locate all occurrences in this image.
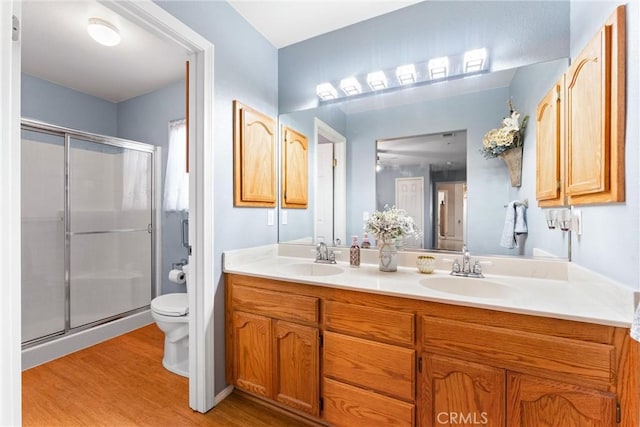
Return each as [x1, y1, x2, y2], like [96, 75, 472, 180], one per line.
[480, 101, 529, 187]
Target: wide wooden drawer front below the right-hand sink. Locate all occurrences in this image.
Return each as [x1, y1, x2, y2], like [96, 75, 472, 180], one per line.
[422, 316, 615, 387]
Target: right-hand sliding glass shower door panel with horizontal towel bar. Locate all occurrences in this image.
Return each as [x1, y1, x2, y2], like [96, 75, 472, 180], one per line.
[68, 138, 153, 328]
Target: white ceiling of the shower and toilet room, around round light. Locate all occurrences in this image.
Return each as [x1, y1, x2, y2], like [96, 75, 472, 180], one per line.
[22, 0, 186, 102]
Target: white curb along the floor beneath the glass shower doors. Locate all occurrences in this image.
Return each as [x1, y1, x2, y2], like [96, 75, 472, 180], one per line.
[22, 310, 153, 371]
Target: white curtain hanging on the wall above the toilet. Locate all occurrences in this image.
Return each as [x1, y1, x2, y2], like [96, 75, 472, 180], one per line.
[163, 120, 189, 211]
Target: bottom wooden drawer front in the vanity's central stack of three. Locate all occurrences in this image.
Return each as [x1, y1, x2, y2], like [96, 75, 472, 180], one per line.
[323, 378, 415, 427]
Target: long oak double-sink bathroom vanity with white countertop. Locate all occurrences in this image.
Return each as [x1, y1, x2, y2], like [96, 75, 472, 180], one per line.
[224, 245, 640, 427]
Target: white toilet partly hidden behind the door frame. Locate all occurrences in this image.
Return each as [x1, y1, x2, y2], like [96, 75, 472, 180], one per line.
[151, 266, 189, 378]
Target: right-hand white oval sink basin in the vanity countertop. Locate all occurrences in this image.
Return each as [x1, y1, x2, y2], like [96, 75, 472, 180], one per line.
[420, 276, 519, 299]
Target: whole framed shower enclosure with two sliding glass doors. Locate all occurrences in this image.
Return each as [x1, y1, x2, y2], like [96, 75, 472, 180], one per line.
[21, 120, 159, 346]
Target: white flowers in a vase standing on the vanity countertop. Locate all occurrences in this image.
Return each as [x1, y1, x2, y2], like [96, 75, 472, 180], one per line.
[364, 205, 420, 271]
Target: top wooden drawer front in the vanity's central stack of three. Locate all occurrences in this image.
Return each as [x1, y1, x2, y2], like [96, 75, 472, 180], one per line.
[323, 301, 415, 345]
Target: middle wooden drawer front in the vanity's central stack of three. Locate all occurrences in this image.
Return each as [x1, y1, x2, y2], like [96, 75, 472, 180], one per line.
[323, 332, 415, 401]
